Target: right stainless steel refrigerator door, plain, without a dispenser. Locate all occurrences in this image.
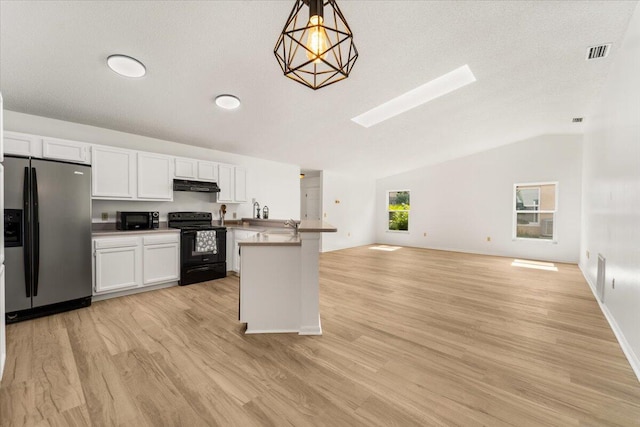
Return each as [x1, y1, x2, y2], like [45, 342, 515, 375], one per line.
[31, 159, 91, 308]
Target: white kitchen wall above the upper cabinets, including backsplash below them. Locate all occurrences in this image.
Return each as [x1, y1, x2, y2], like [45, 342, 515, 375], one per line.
[4, 111, 300, 221]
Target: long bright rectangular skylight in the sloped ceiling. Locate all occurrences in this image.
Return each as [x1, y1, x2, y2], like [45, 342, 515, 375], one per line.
[351, 65, 476, 128]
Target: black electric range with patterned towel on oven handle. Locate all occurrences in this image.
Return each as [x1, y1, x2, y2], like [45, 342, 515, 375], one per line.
[169, 212, 227, 285]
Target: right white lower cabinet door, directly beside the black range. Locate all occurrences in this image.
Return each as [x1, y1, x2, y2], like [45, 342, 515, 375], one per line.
[143, 234, 180, 285]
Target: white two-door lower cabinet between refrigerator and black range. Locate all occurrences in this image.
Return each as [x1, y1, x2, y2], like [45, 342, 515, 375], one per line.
[93, 233, 180, 295]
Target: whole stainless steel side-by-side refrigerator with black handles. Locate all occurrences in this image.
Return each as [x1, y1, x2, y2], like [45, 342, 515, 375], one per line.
[3, 157, 91, 322]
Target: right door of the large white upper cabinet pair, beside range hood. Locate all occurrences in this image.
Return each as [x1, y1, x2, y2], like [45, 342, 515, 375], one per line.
[137, 153, 174, 200]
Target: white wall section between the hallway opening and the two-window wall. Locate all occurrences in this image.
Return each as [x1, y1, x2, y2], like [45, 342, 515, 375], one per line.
[321, 171, 375, 252]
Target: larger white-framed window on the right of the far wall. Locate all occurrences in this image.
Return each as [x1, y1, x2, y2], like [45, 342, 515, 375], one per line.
[513, 182, 558, 241]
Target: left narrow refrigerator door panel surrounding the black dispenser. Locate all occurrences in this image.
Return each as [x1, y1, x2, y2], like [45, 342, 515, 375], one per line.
[3, 157, 31, 313]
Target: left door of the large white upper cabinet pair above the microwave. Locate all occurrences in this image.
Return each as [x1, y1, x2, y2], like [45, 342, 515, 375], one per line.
[91, 145, 136, 200]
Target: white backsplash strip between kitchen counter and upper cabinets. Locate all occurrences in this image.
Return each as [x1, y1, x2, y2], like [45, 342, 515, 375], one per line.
[91, 191, 240, 222]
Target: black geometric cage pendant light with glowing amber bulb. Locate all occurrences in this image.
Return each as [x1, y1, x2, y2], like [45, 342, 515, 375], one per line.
[273, 0, 358, 90]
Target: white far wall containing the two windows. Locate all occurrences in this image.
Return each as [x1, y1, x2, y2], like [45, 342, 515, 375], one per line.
[376, 135, 582, 263]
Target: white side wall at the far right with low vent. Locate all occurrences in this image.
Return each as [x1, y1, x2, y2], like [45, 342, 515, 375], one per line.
[580, 2, 640, 379]
